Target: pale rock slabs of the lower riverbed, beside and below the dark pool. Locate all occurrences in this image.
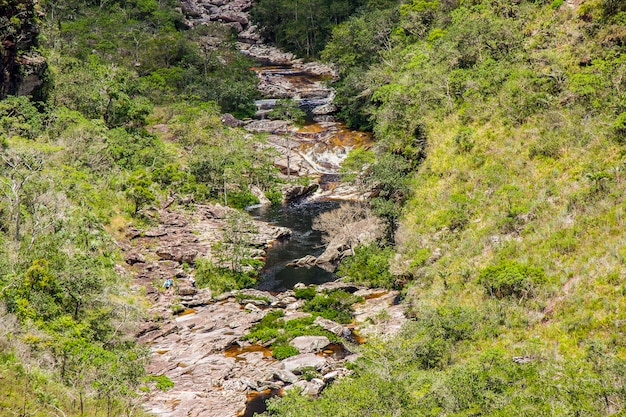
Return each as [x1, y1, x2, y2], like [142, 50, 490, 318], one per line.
[118, 205, 405, 417]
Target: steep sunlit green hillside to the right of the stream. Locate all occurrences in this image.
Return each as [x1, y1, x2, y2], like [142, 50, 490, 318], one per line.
[262, 0, 626, 416]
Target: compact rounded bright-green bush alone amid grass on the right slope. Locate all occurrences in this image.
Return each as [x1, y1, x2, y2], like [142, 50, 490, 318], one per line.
[479, 261, 546, 298]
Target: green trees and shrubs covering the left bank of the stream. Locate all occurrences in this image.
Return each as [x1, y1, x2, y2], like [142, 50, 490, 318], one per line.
[0, 0, 277, 417]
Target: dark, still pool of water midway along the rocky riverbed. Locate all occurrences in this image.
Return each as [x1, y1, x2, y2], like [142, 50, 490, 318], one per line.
[250, 201, 339, 291]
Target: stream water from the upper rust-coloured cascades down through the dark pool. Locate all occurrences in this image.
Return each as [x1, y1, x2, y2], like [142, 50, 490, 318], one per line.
[250, 65, 372, 291]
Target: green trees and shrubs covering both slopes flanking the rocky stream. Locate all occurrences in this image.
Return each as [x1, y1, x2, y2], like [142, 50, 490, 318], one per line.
[0, 0, 626, 417]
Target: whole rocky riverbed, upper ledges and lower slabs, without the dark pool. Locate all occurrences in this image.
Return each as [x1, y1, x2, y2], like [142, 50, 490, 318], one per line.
[127, 0, 406, 417]
